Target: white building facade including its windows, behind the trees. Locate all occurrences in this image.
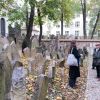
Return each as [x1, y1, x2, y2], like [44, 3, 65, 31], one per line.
[43, 14, 90, 36]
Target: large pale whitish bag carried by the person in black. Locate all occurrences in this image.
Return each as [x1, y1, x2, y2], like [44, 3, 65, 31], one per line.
[67, 47, 78, 66]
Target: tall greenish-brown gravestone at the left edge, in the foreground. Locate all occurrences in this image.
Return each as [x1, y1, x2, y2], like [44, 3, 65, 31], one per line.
[0, 52, 13, 100]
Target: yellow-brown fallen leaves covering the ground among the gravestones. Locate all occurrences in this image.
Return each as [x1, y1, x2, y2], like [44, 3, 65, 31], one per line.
[21, 56, 88, 100]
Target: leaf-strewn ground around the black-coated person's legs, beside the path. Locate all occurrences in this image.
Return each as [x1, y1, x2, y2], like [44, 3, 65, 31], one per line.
[48, 58, 88, 100]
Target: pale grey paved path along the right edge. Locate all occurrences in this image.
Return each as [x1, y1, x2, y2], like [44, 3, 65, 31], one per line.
[85, 57, 100, 100]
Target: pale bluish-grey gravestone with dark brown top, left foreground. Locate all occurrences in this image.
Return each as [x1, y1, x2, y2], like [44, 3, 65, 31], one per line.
[11, 61, 27, 100]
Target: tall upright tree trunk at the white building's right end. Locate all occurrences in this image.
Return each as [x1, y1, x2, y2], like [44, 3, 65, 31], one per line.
[81, 0, 87, 39]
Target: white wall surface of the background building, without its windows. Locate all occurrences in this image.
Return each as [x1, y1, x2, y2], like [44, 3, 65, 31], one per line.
[43, 14, 89, 36]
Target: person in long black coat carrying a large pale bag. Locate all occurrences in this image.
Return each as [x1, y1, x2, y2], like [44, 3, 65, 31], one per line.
[69, 41, 80, 88]
